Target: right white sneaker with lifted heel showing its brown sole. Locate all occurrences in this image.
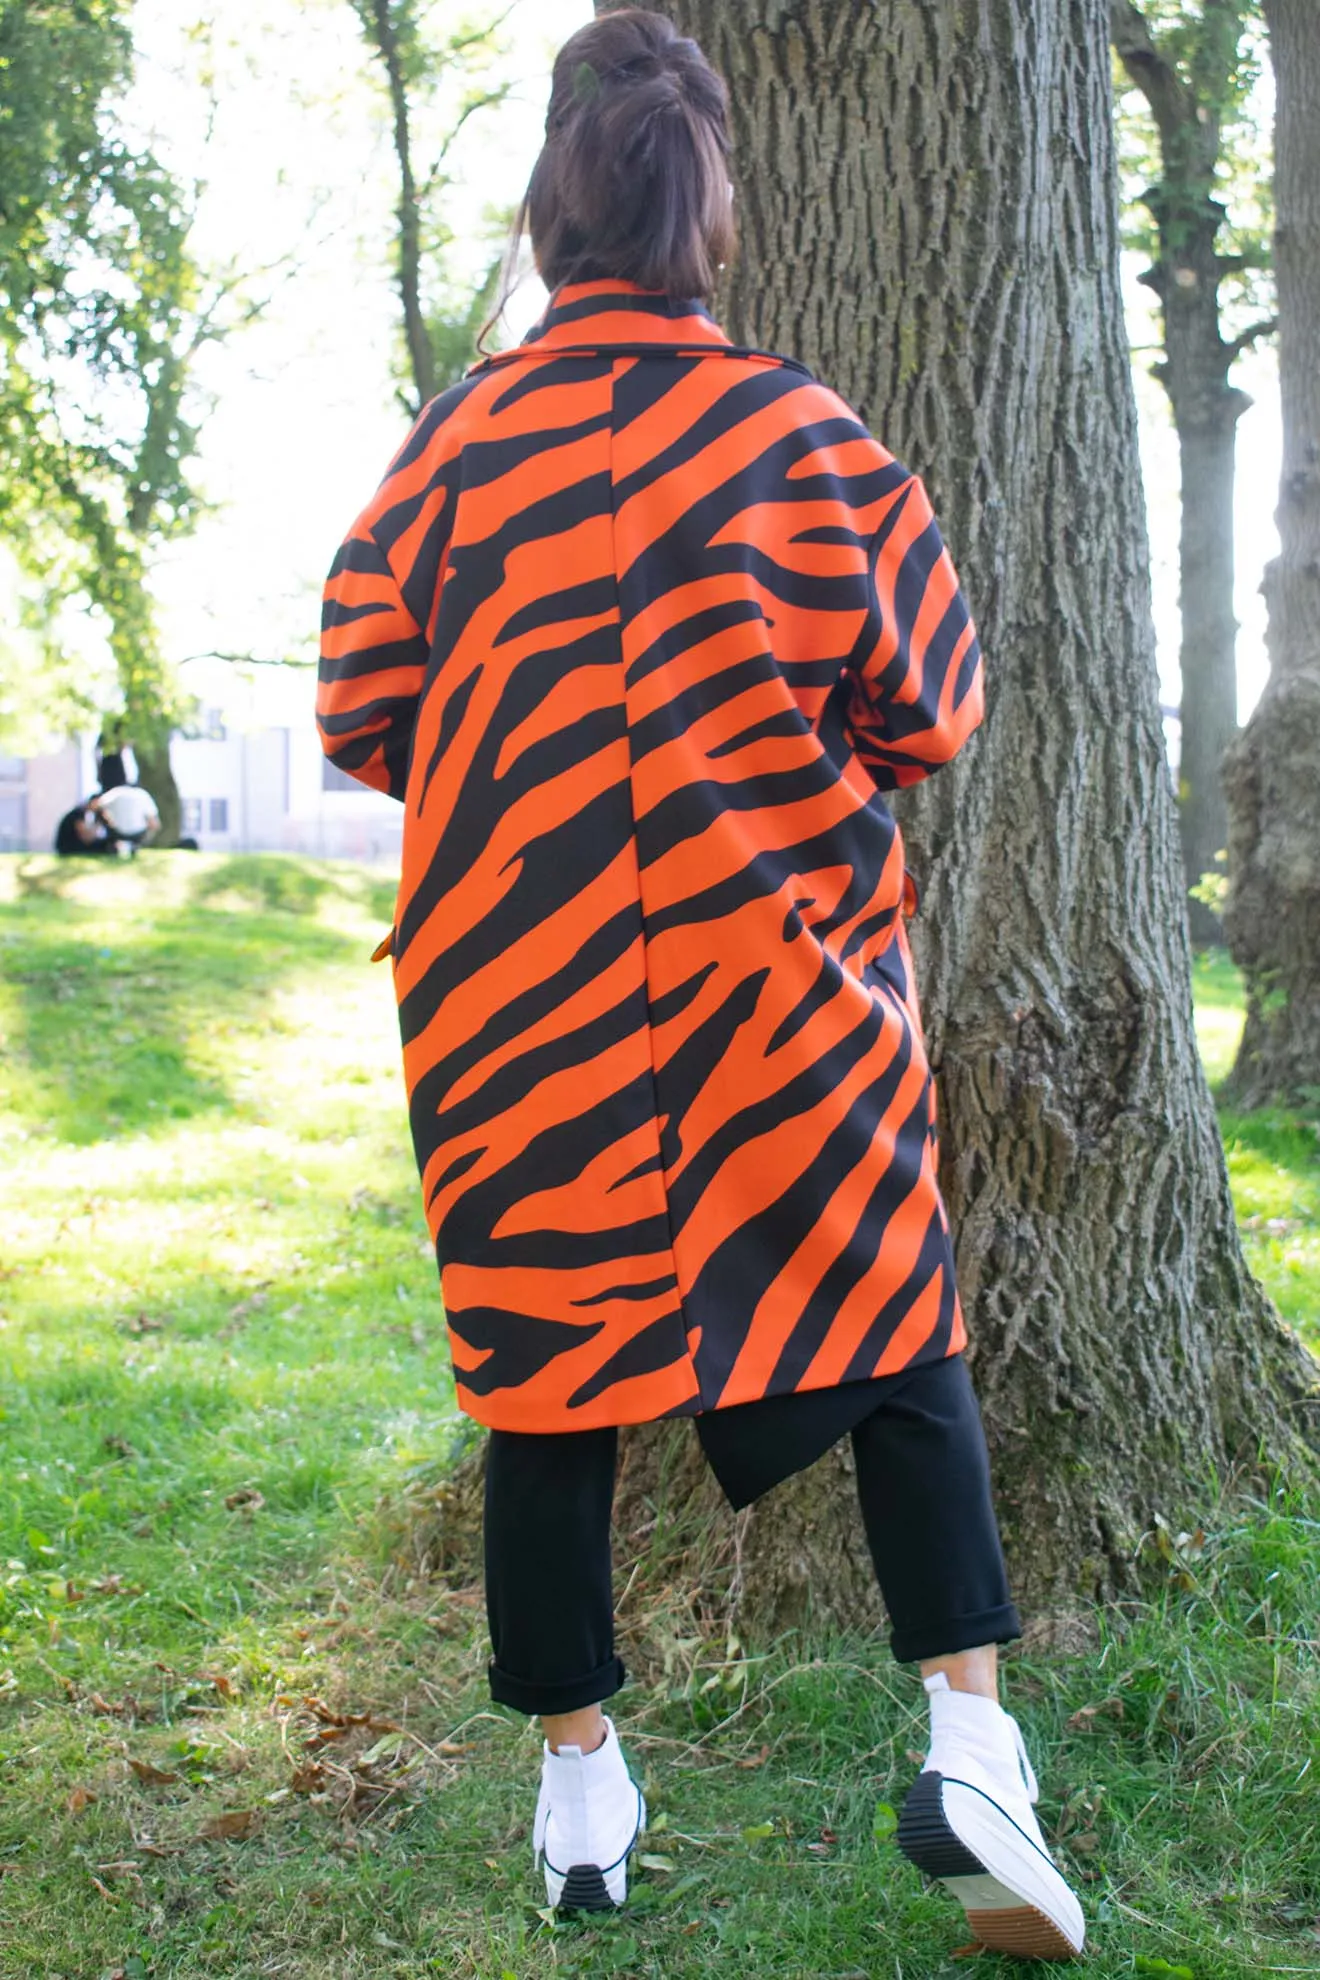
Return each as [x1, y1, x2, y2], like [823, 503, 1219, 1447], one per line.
[898, 1671, 1086, 1960]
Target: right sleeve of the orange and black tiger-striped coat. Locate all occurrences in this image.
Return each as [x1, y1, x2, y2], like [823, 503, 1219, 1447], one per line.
[847, 475, 984, 790]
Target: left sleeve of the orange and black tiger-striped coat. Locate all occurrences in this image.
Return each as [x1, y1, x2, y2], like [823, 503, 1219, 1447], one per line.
[317, 394, 465, 800]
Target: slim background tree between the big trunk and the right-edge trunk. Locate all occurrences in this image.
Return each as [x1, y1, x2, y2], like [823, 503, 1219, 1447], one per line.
[1110, 0, 1274, 941]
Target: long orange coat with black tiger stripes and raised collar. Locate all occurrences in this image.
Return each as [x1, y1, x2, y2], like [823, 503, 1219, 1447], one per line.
[319, 283, 982, 1432]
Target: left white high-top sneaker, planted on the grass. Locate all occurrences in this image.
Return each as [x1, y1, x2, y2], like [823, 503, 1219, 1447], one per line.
[532, 1719, 647, 1911]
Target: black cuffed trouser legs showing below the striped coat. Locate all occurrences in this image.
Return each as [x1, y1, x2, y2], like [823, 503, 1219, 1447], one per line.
[485, 1354, 1021, 1715]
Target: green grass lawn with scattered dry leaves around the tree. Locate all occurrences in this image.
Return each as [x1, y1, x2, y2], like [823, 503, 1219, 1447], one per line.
[0, 853, 1320, 1980]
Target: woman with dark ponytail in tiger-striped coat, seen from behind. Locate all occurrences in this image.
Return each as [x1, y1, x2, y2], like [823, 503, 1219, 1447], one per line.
[319, 8, 1083, 1958]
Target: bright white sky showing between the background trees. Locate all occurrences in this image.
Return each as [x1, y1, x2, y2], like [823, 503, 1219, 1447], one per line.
[123, 0, 1278, 736]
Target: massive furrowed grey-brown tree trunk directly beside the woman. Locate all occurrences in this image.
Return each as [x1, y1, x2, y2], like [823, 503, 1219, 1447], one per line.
[569, 0, 1318, 1624]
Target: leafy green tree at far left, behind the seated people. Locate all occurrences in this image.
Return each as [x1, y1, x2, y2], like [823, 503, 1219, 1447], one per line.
[0, 0, 196, 830]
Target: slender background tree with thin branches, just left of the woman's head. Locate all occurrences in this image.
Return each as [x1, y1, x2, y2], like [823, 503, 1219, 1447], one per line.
[352, 0, 511, 414]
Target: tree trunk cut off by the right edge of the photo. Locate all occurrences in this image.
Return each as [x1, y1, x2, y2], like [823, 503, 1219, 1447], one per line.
[1225, 0, 1320, 1105]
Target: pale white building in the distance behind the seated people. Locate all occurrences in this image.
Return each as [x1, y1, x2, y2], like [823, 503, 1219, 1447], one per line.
[0, 661, 404, 865]
